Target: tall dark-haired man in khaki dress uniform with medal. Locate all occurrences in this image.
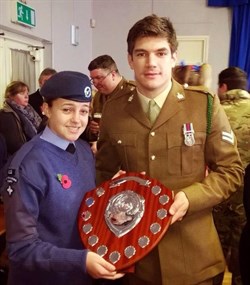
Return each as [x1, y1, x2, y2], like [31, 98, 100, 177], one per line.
[96, 15, 243, 285]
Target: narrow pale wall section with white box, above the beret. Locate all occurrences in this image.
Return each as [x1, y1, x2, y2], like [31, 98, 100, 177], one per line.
[52, 0, 92, 73]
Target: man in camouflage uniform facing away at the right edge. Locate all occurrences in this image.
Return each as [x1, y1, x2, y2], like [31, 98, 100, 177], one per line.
[214, 67, 250, 285]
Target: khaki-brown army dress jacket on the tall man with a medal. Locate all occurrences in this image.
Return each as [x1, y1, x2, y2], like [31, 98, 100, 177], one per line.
[96, 80, 243, 285]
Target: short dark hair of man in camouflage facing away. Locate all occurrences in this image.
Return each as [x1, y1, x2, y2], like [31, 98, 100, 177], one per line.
[218, 66, 247, 90]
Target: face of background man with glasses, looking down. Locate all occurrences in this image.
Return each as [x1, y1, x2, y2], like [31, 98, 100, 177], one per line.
[90, 68, 115, 94]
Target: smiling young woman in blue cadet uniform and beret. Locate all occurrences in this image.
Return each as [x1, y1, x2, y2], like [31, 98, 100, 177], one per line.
[2, 71, 123, 285]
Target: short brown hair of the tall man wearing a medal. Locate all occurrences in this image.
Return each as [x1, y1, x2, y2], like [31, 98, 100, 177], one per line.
[127, 14, 178, 55]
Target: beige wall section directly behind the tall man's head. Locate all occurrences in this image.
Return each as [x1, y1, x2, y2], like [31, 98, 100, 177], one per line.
[92, 0, 231, 91]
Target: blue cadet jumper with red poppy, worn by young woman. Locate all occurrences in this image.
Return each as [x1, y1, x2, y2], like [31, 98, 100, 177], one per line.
[2, 129, 95, 285]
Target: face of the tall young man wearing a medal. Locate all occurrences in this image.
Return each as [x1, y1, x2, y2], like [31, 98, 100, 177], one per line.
[128, 37, 176, 98]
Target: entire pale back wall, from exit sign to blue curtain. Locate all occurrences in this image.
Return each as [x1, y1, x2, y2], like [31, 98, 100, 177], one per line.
[0, 0, 231, 92]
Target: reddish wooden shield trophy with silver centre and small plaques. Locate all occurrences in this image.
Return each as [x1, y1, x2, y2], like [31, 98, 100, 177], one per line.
[78, 172, 173, 271]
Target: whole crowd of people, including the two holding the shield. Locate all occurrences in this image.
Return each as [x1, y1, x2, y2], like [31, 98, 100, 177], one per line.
[0, 12, 250, 285]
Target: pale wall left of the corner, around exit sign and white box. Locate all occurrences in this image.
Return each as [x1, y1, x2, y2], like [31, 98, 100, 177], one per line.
[0, 0, 92, 79]
